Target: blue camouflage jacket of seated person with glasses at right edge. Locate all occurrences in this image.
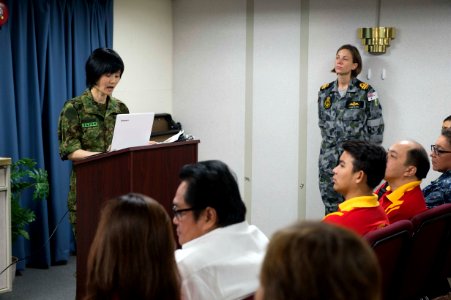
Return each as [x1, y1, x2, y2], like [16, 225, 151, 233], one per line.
[423, 170, 451, 208]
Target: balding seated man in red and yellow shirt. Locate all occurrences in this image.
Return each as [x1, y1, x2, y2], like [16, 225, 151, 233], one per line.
[379, 141, 430, 223]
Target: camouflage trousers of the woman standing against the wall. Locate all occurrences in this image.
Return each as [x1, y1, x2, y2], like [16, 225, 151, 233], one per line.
[318, 147, 344, 215]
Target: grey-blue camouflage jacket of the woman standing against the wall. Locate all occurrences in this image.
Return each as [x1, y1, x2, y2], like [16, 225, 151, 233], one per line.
[318, 78, 384, 148]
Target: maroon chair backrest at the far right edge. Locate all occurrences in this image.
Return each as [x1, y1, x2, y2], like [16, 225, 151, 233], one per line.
[397, 204, 451, 299]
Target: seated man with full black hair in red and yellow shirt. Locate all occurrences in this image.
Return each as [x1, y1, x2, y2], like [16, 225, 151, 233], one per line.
[323, 141, 389, 235]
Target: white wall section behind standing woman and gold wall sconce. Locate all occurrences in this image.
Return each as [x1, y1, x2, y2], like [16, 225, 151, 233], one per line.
[307, 0, 451, 218]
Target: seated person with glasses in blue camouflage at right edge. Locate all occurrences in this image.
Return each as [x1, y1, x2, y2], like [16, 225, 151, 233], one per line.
[423, 129, 451, 208]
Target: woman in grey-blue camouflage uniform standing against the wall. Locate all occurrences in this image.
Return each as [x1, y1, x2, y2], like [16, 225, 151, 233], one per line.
[318, 45, 384, 214]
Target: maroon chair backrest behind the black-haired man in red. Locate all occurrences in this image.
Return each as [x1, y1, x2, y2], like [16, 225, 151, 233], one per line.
[363, 220, 413, 299]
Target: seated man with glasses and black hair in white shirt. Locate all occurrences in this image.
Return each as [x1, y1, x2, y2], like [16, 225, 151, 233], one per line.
[173, 161, 268, 300]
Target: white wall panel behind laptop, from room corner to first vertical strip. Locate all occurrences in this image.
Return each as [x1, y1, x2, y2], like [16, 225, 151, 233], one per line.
[173, 0, 246, 209]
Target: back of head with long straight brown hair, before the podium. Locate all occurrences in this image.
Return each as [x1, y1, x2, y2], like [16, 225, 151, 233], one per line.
[85, 193, 180, 300]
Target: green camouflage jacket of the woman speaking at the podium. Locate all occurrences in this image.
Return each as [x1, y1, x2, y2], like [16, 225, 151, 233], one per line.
[58, 90, 129, 160]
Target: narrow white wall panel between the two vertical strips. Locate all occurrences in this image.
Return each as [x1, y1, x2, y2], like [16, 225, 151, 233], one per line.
[251, 0, 301, 234]
